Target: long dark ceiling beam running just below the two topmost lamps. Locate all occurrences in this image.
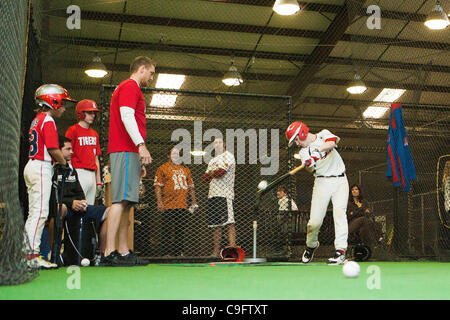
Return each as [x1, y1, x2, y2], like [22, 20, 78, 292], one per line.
[50, 7, 450, 50]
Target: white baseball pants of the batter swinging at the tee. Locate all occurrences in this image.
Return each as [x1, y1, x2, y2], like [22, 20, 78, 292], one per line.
[306, 176, 349, 251]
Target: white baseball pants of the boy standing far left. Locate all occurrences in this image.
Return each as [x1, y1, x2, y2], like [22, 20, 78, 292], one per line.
[23, 160, 53, 254]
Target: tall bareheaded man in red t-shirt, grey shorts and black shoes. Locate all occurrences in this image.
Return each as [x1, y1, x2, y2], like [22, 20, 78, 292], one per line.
[101, 56, 155, 266]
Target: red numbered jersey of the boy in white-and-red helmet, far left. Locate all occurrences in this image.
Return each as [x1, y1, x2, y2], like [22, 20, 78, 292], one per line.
[28, 112, 59, 161]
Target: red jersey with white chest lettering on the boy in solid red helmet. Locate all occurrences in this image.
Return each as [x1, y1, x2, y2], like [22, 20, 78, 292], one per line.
[66, 123, 102, 171]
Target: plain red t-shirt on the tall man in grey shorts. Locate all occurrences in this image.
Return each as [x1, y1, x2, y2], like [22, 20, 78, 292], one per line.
[108, 79, 147, 153]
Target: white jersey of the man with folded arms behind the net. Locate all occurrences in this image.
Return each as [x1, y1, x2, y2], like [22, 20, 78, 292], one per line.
[206, 151, 236, 200]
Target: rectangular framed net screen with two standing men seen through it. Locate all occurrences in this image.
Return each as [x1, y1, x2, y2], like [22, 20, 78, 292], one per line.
[101, 86, 293, 258]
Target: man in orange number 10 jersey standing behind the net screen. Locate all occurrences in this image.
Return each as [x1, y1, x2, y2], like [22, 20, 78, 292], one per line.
[153, 147, 198, 256]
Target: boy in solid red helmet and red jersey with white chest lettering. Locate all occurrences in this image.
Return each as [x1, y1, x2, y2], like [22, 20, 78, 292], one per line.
[66, 99, 102, 205]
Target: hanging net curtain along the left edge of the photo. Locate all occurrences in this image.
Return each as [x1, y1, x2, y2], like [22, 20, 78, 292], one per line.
[0, 1, 38, 285]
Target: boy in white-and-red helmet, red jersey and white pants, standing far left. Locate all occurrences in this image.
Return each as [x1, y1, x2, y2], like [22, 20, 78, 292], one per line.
[24, 84, 75, 269]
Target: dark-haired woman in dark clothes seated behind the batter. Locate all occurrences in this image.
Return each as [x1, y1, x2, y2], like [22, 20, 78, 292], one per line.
[347, 184, 382, 246]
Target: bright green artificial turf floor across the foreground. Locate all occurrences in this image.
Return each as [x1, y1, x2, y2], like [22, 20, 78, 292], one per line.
[0, 262, 450, 300]
